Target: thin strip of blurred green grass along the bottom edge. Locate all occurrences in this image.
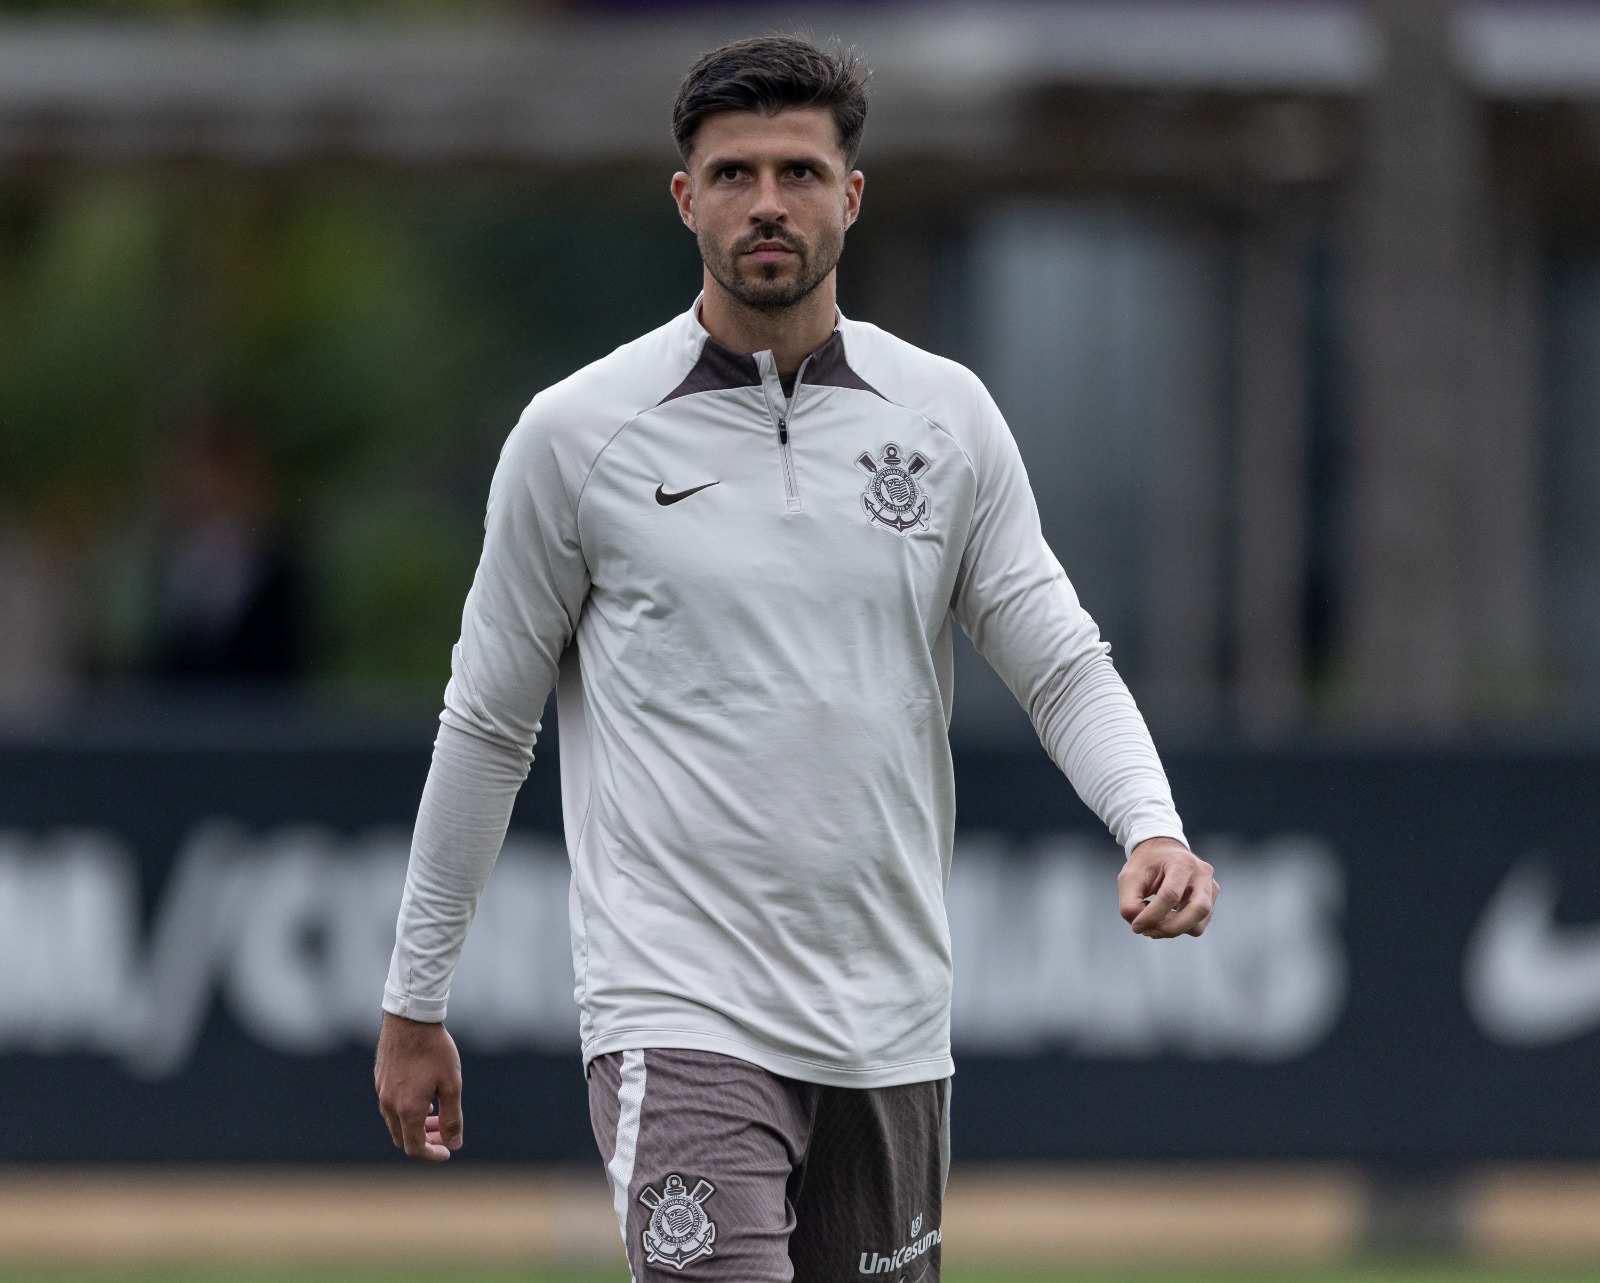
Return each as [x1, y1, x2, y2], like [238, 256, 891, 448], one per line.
[0, 1264, 1600, 1283]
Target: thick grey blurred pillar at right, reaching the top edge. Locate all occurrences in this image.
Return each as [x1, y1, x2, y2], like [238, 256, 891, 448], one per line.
[1344, 0, 1486, 734]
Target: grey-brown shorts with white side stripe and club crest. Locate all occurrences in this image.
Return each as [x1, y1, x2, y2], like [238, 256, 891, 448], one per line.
[589, 1048, 950, 1283]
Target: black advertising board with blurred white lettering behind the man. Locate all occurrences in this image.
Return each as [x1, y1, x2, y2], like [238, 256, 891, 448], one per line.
[0, 729, 1600, 1163]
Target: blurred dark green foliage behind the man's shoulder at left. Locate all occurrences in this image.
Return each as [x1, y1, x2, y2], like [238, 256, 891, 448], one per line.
[0, 171, 699, 705]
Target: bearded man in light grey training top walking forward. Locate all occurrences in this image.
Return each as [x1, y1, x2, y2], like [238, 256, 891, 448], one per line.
[376, 37, 1216, 1283]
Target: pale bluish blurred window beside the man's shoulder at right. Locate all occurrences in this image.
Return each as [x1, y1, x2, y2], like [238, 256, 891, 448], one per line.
[941, 200, 1227, 744]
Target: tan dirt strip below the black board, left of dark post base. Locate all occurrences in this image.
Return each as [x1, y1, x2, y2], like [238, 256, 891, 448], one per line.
[0, 1165, 1363, 1269]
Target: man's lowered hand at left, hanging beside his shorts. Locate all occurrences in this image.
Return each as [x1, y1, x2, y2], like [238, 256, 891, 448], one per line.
[373, 1011, 462, 1163]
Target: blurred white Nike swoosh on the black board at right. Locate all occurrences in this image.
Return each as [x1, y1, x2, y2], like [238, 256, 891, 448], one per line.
[1464, 859, 1600, 1048]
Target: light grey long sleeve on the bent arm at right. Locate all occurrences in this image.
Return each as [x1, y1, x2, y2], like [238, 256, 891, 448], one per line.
[954, 381, 1184, 851]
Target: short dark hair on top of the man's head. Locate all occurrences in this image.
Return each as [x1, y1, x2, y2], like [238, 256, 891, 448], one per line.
[672, 35, 867, 168]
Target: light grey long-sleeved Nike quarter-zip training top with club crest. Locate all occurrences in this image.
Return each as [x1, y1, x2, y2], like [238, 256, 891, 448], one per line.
[384, 306, 1182, 1086]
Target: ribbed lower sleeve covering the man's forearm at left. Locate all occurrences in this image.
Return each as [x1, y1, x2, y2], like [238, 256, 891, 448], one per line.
[384, 713, 528, 1021]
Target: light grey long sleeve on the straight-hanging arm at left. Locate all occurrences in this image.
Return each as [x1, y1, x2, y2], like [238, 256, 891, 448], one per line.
[384, 400, 589, 1021]
